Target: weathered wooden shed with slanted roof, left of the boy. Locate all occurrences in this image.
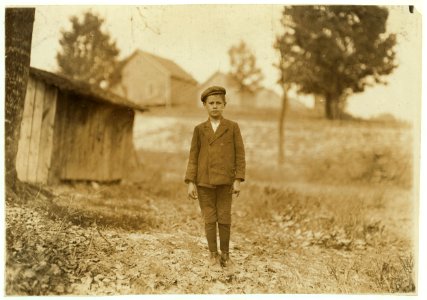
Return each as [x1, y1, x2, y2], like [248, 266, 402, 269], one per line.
[16, 68, 145, 183]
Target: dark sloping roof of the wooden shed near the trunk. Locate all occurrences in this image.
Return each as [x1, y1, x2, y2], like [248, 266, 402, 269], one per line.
[30, 67, 148, 111]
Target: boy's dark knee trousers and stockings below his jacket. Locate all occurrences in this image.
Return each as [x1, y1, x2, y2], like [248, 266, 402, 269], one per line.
[197, 185, 232, 253]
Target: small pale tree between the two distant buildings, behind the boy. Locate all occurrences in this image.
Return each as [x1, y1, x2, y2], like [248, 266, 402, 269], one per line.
[228, 41, 264, 93]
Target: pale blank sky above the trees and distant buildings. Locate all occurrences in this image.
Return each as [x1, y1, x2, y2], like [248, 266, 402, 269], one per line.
[31, 4, 421, 120]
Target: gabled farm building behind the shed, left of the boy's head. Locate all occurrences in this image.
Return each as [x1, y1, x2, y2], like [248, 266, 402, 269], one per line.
[111, 50, 197, 107]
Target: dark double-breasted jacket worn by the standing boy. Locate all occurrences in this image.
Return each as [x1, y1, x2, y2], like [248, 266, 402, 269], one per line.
[185, 118, 246, 186]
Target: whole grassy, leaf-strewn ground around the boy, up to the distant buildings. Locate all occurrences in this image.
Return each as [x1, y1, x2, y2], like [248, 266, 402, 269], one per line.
[6, 108, 417, 295]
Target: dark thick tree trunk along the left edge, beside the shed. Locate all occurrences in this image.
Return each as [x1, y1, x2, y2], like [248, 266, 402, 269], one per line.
[5, 8, 35, 198]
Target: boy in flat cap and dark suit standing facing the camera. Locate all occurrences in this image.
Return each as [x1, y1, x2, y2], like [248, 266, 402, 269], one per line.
[185, 86, 246, 269]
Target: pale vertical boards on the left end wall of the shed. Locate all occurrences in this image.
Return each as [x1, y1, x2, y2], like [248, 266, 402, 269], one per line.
[16, 76, 57, 183]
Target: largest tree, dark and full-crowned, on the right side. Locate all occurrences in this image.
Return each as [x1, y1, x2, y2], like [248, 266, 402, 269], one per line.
[276, 5, 397, 119]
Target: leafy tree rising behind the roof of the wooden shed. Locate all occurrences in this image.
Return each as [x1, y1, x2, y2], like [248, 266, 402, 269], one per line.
[56, 12, 119, 88]
